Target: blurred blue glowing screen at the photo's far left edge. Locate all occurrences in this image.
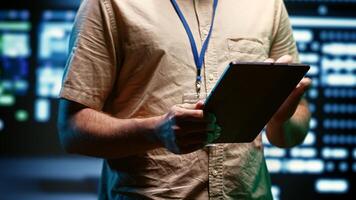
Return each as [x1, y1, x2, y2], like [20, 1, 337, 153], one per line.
[0, 10, 32, 126]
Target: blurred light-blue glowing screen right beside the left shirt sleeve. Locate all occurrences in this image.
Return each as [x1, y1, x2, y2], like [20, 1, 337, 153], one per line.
[34, 10, 75, 122]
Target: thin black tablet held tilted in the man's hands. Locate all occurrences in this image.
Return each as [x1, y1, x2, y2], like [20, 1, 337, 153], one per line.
[204, 62, 310, 143]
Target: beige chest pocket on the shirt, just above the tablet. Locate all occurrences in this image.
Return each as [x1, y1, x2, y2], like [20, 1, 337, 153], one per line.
[227, 38, 269, 62]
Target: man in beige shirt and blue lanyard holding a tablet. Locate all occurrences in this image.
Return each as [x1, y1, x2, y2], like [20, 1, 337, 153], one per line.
[59, 0, 310, 199]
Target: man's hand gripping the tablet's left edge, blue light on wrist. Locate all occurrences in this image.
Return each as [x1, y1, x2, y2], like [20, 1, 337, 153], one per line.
[156, 101, 219, 154]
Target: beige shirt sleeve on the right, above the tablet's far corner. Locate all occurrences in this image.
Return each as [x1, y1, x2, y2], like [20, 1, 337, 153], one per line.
[269, 0, 299, 63]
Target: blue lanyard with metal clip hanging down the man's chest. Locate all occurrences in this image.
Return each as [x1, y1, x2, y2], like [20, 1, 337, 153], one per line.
[171, 0, 218, 95]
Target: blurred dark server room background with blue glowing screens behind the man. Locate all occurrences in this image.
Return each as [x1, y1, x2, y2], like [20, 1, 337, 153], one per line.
[0, 0, 356, 200]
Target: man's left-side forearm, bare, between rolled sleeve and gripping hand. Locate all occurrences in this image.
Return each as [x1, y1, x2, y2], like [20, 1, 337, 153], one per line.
[59, 105, 164, 158]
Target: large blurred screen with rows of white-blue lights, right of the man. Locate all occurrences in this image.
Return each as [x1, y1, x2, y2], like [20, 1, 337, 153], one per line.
[264, 12, 356, 199]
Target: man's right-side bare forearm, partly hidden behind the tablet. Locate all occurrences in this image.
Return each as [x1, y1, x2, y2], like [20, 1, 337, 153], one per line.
[266, 99, 310, 148]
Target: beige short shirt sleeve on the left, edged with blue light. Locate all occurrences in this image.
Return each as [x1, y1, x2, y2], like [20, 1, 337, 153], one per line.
[60, 0, 119, 110]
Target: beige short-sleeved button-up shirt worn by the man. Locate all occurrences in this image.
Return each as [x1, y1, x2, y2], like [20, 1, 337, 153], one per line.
[60, 0, 297, 199]
